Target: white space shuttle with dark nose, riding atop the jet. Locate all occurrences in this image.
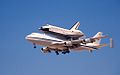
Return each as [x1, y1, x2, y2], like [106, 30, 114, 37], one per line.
[39, 22, 84, 37]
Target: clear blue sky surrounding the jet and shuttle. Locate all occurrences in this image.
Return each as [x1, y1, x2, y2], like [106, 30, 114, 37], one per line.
[0, 0, 120, 75]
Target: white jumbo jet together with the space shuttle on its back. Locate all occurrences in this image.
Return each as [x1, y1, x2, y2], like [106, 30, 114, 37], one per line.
[25, 22, 112, 55]
